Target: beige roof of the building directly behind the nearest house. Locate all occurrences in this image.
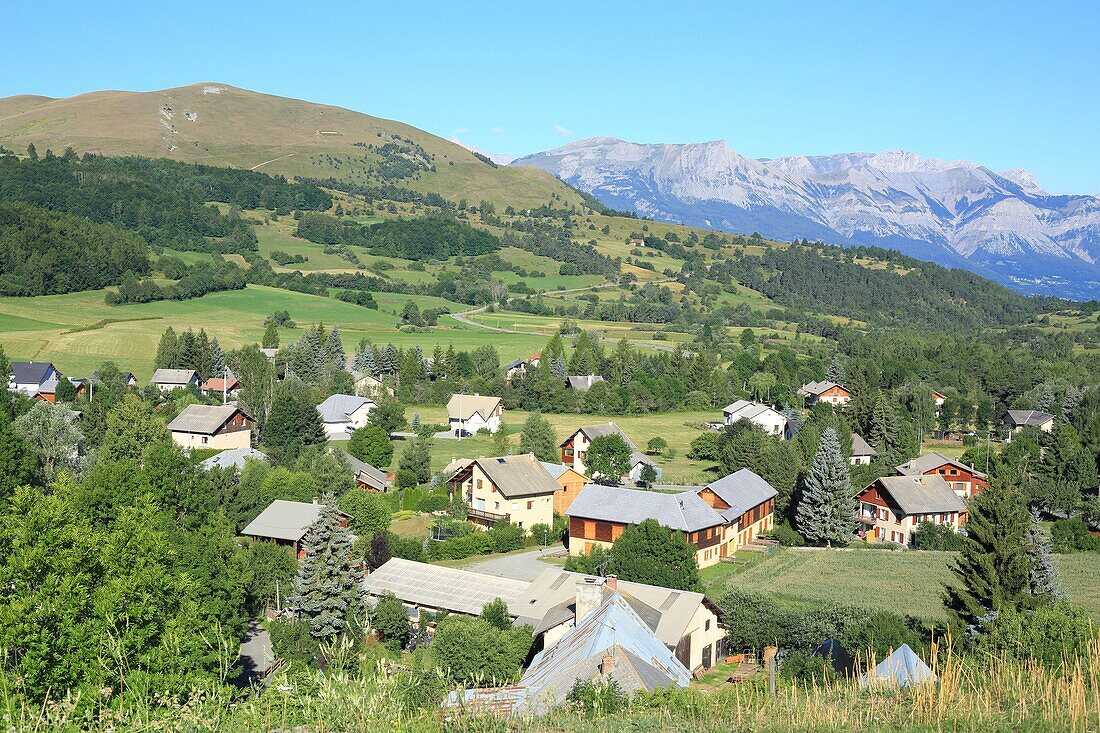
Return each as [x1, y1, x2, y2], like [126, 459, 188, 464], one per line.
[508, 568, 710, 646]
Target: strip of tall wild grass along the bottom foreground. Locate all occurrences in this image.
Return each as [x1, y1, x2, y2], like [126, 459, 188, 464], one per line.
[0, 639, 1100, 733]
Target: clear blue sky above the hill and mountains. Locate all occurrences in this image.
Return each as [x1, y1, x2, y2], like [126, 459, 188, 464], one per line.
[0, 0, 1100, 194]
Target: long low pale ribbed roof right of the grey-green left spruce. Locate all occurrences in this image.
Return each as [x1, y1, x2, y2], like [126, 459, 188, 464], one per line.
[362, 557, 528, 615]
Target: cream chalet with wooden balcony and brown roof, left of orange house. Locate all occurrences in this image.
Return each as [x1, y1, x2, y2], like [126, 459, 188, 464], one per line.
[451, 453, 560, 532]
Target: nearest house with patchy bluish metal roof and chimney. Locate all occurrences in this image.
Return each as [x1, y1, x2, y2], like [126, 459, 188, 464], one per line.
[444, 578, 692, 715]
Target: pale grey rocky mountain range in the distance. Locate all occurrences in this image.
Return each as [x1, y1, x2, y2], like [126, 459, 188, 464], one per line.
[512, 138, 1100, 299]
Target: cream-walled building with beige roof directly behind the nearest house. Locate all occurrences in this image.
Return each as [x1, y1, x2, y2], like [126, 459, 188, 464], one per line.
[508, 568, 726, 671]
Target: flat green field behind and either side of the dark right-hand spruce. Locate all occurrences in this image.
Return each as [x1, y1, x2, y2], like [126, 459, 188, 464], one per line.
[704, 548, 1100, 621]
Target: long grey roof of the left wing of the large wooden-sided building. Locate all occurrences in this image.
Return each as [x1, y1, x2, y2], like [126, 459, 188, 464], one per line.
[565, 483, 726, 532]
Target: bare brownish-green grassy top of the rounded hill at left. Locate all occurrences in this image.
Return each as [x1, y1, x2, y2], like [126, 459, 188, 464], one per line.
[0, 83, 581, 208]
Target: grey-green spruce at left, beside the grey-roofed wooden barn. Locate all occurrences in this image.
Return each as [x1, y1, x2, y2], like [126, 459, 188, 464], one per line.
[287, 494, 360, 639]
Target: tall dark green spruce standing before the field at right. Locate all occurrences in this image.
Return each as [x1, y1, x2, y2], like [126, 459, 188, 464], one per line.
[944, 483, 1032, 634]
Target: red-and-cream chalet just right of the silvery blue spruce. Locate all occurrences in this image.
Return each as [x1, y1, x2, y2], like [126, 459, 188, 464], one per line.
[856, 473, 966, 545]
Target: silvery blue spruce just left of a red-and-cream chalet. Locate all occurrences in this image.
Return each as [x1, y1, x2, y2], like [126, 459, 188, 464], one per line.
[795, 427, 856, 546]
